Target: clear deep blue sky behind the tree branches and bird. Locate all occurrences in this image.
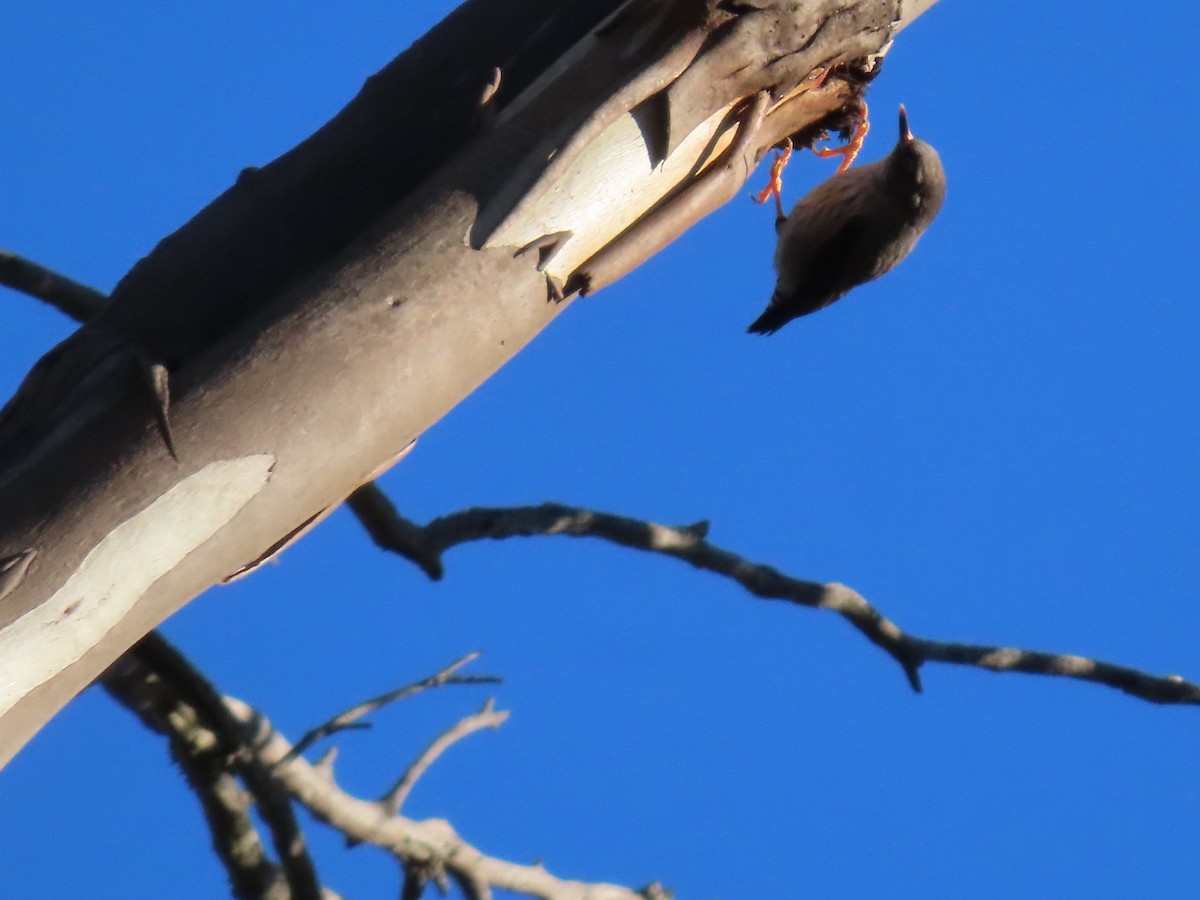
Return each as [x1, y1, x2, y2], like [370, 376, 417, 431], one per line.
[0, 0, 1200, 900]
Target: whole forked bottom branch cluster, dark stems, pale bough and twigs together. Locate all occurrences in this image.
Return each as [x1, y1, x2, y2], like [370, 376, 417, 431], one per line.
[103, 635, 648, 900]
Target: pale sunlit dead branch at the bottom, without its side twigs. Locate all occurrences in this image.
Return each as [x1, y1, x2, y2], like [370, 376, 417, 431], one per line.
[224, 697, 649, 900]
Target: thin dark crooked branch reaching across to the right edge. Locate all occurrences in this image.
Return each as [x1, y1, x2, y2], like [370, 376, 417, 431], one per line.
[352, 503, 1200, 706]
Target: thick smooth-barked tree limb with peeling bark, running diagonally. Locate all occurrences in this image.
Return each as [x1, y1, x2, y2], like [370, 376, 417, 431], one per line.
[0, 0, 924, 762]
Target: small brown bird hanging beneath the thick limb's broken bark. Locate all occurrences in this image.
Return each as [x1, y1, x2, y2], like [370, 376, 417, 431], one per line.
[746, 106, 946, 335]
